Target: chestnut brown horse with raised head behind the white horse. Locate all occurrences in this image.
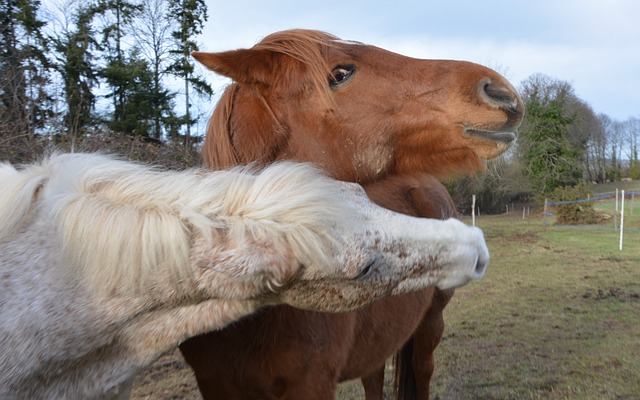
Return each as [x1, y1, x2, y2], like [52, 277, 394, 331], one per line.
[180, 30, 524, 400]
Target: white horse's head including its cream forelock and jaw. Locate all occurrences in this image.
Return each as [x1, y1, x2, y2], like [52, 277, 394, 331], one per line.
[144, 163, 489, 312]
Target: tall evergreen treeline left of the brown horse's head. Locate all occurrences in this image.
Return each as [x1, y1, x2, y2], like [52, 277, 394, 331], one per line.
[0, 0, 213, 162]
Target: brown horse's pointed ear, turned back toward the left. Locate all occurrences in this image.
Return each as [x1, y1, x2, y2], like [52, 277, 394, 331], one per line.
[191, 49, 285, 84]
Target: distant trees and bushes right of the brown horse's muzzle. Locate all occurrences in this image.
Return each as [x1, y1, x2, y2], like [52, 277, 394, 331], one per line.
[449, 74, 640, 213]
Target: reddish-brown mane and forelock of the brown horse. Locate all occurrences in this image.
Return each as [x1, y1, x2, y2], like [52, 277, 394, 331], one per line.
[202, 29, 338, 169]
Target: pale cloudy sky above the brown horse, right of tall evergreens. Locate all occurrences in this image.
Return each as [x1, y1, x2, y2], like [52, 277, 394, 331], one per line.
[199, 0, 640, 121]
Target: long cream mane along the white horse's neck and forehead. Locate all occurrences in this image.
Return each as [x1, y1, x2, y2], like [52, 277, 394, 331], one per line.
[0, 154, 349, 293]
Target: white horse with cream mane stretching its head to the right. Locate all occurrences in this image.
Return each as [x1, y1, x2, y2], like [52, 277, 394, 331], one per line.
[0, 154, 488, 399]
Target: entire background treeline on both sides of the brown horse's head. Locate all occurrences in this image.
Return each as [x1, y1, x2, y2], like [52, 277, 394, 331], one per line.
[0, 0, 640, 213]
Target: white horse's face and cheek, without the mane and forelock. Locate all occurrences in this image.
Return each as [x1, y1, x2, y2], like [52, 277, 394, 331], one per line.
[193, 181, 489, 312]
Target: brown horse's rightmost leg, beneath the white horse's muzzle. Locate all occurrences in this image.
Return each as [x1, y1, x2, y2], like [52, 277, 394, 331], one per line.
[411, 289, 454, 400]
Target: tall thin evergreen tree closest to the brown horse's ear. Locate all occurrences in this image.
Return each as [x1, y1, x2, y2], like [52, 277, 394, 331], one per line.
[169, 0, 213, 146]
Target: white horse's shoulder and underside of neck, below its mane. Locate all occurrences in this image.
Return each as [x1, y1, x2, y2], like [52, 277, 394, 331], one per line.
[0, 218, 254, 399]
